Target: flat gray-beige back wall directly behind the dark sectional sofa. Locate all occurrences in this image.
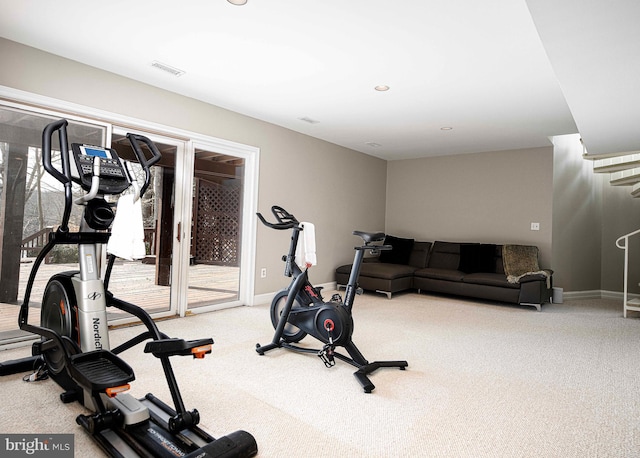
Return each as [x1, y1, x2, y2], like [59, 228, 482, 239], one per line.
[386, 147, 553, 267]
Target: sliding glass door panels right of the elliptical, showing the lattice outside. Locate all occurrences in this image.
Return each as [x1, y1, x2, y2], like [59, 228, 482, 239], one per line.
[110, 128, 252, 316]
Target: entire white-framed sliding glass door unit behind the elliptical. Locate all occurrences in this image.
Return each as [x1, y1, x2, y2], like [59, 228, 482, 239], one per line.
[0, 91, 259, 345]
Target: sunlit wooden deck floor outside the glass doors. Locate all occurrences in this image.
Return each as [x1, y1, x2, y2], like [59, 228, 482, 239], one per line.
[0, 261, 240, 343]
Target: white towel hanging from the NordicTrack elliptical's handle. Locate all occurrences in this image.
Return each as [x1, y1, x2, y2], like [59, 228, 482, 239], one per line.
[107, 193, 146, 261]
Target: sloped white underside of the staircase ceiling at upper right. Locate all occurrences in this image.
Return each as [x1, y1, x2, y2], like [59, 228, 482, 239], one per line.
[527, 0, 640, 154]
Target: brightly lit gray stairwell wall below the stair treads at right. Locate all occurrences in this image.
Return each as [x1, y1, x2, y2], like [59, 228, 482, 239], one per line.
[553, 134, 640, 293]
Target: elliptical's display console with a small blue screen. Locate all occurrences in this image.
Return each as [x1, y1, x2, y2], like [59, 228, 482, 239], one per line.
[70, 143, 131, 194]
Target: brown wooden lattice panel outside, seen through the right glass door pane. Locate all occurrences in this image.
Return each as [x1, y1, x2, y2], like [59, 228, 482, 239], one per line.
[194, 180, 242, 267]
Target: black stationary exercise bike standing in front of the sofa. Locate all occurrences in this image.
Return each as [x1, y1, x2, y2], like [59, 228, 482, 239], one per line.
[256, 206, 408, 393]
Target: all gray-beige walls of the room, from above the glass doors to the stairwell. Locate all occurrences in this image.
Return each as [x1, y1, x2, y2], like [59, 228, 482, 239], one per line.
[0, 39, 640, 294]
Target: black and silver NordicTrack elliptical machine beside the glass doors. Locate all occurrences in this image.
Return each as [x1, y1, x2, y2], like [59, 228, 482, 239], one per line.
[0, 119, 257, 458]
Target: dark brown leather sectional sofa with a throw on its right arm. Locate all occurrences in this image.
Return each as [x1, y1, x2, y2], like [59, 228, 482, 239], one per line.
[336, 236, 553, 311]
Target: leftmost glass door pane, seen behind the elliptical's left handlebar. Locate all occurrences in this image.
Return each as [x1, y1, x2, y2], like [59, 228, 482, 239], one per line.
[0, 106, 106, 342]
